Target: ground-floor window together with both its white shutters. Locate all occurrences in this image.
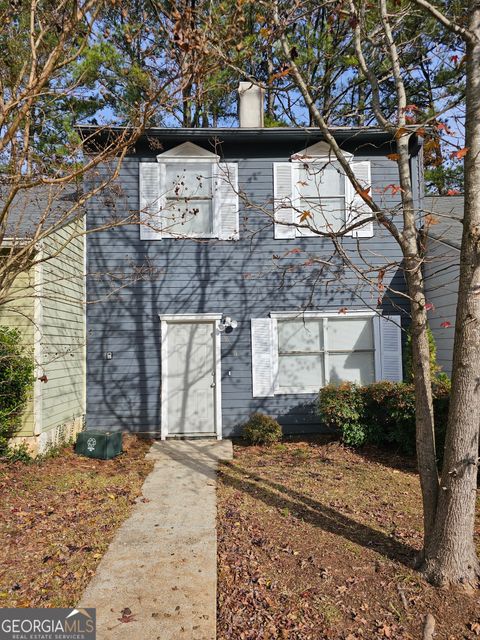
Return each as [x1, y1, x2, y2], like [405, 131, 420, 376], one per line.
[252, 311, 402, 397]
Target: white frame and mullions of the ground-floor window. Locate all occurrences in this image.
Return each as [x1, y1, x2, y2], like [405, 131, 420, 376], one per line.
[270, 310, 381, 395]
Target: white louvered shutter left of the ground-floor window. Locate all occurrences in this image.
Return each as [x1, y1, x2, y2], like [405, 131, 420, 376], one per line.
[252, 318, 278, 398]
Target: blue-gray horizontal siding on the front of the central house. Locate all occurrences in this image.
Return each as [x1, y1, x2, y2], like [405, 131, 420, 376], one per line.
[87, 133, 412, 436]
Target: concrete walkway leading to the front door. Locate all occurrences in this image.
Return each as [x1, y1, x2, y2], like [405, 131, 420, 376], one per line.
[78, 440, 232, 640]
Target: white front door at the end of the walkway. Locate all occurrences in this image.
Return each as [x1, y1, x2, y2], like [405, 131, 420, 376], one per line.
[162, 322, 217, 436]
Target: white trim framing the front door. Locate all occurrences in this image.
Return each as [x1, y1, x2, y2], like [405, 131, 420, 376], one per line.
[159, 313, 222, 440]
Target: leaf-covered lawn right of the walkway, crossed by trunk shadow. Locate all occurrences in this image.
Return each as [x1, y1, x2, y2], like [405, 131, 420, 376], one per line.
[218, 439, 480, 640]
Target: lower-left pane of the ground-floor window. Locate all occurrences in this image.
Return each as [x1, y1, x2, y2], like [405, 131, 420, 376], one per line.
[278, 355, 324, 393]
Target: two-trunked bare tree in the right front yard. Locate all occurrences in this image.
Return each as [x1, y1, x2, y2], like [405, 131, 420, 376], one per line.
[274, 0, 480, 584]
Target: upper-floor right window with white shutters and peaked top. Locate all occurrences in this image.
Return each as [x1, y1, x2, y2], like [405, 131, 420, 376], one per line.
[274, 142, 373, 239]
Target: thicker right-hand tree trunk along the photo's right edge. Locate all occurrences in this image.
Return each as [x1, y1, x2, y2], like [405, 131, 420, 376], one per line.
[424, 0, 480, 586]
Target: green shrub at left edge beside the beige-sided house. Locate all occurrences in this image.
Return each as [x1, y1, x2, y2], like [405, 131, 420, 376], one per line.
[0, 327, 34, 455]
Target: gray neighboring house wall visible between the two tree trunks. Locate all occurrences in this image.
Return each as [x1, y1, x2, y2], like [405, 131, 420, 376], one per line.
[423, 196, 464, 375]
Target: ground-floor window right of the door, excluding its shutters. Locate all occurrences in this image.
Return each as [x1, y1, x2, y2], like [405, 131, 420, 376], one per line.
[276, 317, 375, 393]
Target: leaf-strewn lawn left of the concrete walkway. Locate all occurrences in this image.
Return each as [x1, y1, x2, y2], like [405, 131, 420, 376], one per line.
[0, 436, 153, 607]
